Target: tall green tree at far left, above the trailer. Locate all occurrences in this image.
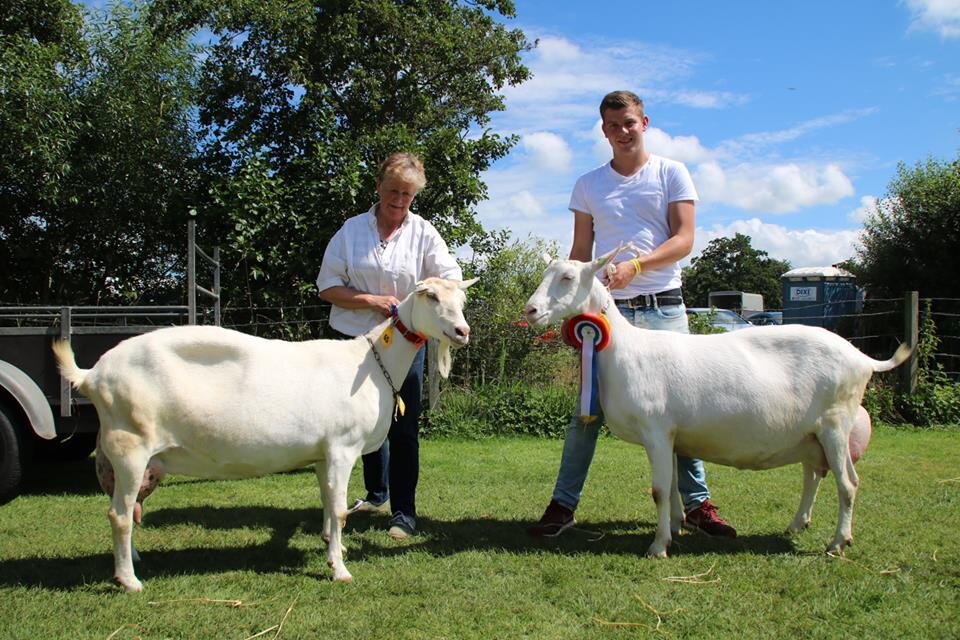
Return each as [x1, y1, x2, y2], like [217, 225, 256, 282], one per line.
[0, 0, 197, 304]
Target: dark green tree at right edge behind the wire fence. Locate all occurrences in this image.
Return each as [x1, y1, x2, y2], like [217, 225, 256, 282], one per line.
[855, 156, 960, 298]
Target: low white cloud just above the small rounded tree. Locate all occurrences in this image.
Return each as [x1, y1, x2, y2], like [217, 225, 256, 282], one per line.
[686, 218, 860, 268]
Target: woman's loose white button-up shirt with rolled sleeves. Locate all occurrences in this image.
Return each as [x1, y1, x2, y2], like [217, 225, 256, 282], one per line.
[317, 205, 463, 336]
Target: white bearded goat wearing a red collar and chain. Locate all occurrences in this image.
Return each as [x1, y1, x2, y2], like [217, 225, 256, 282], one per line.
[53, 278, 474, 591]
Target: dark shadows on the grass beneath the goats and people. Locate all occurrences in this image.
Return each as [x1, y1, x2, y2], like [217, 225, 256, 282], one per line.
[0, 507, 795, 590]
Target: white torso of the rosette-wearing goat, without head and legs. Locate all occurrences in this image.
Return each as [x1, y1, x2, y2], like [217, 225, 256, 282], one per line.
[598, 322, 874, 469]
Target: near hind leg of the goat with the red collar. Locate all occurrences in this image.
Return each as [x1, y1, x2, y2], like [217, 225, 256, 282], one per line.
[103, 431, 150, 591]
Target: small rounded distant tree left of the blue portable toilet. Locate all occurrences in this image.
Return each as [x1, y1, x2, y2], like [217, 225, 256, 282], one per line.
[683, 233, 791, 309]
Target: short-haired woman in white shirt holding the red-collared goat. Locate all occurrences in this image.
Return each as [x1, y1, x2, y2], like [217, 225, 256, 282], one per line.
[317, 153, 463, 539]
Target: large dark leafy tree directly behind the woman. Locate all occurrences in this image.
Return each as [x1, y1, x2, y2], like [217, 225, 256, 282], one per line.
[153, 0, 529, 330]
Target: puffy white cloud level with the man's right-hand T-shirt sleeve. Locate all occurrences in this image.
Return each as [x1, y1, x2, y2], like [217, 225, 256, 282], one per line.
[692, 161, 854, 213]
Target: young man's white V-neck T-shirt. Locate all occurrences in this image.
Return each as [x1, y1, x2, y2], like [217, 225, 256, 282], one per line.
[570, 154, 699, 299]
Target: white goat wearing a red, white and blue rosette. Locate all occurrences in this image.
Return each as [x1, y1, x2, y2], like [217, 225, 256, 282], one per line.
[526, 248, 910, 558]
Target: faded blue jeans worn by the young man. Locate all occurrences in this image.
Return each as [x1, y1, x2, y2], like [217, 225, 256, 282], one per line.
[553, 304, 710, 511]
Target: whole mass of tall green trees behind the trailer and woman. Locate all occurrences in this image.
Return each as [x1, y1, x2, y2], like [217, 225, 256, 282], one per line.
[0, 0, 530, 319]
